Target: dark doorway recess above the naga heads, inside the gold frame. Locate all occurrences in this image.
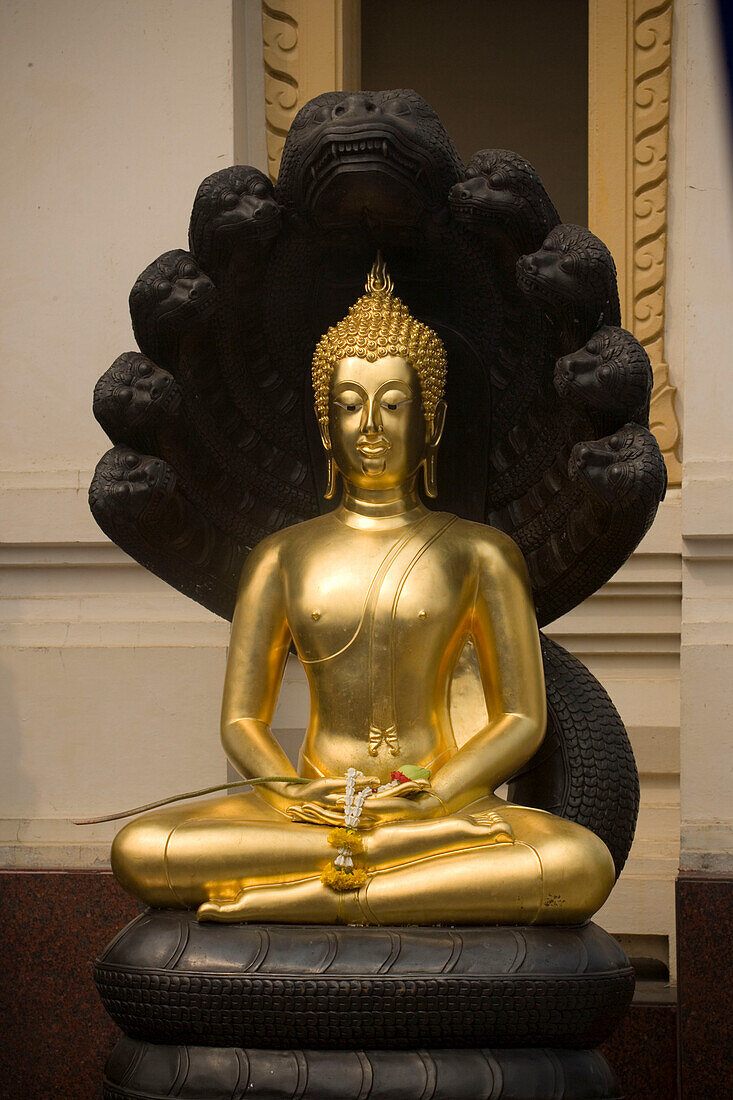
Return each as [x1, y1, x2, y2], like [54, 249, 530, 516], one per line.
[361, 0, 588, 226]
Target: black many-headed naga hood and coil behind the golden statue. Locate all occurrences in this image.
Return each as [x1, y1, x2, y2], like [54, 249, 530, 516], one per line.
[90, 91, 666, 870]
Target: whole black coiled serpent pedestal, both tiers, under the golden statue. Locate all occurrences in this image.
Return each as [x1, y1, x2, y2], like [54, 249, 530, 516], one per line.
[95, 910, 634, 1100]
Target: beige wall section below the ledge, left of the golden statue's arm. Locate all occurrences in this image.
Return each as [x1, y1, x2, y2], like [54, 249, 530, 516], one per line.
[0, 642, 226, 817]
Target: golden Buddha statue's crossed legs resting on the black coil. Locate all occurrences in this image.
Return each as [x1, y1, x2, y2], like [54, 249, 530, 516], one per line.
[112, 794, 614, 924]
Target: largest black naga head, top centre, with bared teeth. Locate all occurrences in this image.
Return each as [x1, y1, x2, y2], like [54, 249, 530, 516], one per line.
[275, 91, 463, 231]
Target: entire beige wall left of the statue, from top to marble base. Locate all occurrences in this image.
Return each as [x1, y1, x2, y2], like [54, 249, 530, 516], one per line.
[0, 0, 242, 866]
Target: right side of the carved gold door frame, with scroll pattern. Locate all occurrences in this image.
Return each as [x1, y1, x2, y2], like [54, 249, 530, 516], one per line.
[588, 0, 681, 485]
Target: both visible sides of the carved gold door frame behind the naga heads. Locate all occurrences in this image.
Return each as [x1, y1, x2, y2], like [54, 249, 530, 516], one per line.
[262, 0, 680, 485]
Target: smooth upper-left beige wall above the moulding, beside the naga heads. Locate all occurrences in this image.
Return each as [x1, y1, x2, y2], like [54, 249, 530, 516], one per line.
[0, 0, 232, 470]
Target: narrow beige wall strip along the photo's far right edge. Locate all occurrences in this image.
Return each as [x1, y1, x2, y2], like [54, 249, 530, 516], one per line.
[674, 0, 733, 873]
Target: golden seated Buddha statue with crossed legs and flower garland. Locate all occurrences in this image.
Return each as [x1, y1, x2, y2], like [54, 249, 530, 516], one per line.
[112, 260, 614, 924]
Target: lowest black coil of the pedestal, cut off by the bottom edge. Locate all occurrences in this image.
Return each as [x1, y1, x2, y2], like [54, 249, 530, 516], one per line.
[103, 1038, 621, 1100]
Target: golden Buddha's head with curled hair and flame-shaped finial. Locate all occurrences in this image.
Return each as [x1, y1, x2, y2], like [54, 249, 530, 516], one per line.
[313, 256, 446, 497]
